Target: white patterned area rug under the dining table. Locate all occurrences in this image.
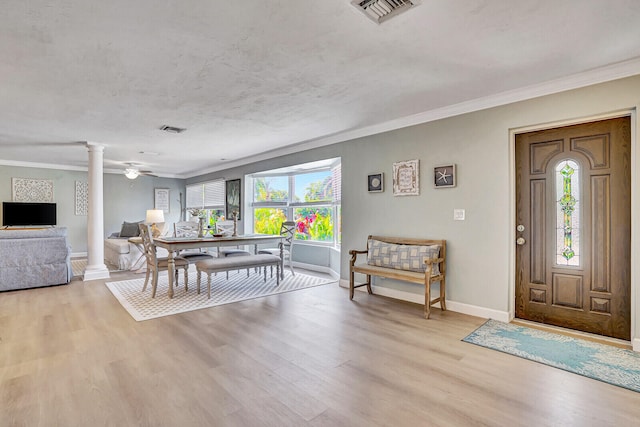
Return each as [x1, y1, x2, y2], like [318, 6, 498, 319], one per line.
[105, 269, 336, 321]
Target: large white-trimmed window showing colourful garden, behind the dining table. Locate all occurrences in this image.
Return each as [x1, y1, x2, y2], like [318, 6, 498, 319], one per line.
[247, 158, 342, 245]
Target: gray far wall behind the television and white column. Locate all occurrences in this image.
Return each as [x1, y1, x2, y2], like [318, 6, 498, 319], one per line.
[0, 166, 185, 254]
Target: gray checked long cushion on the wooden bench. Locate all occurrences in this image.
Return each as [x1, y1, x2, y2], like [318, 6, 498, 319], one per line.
[367, 239, 440, 276]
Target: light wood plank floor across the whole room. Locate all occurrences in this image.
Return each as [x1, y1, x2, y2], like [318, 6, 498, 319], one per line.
[0, 273, 640, 427]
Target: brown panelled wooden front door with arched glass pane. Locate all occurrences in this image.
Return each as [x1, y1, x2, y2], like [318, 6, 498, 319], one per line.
[516, 117, 631, 340]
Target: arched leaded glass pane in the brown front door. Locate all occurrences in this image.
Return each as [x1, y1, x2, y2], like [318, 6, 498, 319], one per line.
[556, 159, 581, 266]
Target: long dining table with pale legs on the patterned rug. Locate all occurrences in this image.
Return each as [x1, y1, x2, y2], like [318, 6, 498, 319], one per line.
[153, 234, 284, 298]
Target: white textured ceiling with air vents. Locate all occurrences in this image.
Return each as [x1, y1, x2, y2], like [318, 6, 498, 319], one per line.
[0, 0, 640, 176]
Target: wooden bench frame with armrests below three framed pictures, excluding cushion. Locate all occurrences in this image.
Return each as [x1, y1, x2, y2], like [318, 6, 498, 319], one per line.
[349, 236, 447, 319]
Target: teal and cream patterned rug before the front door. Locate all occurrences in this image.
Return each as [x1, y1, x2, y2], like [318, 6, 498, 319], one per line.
[462, 320, 640, 392]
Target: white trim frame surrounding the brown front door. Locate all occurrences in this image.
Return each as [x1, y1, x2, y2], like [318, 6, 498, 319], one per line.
[508, 109, 640, 351]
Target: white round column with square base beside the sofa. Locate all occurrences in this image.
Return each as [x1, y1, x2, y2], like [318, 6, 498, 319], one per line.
[84, 142, 109, 281]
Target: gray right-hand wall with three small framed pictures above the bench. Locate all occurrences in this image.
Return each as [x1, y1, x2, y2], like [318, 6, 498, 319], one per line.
[189, 76, 640, 342]
